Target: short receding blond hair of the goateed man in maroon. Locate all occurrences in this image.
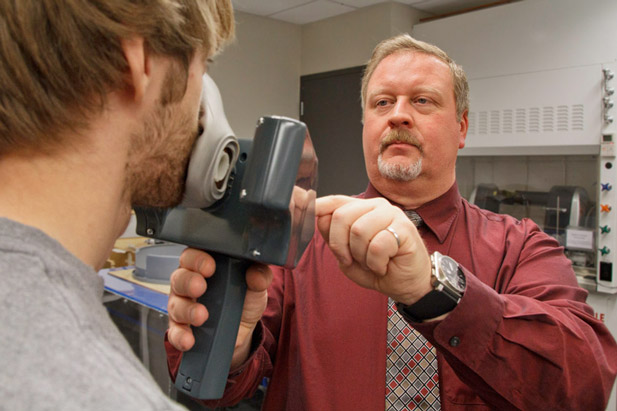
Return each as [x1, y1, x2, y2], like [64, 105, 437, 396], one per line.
[361, 34, 469, 121]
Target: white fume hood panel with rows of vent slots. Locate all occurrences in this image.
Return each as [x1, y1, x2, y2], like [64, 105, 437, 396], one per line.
[460, 65, 602, 155]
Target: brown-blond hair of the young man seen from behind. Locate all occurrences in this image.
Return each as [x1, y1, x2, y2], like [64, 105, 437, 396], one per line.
[0, 0, 234, 155]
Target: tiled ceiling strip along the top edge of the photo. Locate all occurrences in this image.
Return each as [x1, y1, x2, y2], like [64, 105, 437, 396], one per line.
[232, 0, 519, 24]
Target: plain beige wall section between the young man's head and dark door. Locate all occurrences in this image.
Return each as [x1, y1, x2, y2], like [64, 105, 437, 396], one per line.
[209, 12, 301, 138]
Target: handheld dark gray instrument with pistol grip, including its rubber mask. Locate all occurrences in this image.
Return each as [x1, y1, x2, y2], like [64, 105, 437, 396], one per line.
[135, 75, 317, 399]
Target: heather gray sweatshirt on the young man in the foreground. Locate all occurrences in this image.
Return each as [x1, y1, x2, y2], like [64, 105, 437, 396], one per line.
[0, 218, 182, 411]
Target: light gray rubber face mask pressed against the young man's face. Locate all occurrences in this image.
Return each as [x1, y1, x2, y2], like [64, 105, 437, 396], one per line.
[181, 74, 240, 208]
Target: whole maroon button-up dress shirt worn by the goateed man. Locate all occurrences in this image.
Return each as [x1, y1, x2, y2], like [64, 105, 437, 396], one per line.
[166, 184, 617, 411]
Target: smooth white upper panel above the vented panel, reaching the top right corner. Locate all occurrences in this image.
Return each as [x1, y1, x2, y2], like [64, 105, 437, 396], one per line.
[413, 0, 617, 79]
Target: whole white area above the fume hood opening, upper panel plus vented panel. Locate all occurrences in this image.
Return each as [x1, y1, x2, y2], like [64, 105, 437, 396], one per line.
[413, 0, 617, 155]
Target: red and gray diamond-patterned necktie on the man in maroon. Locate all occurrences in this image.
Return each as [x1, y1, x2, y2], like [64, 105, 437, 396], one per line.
[386, 210, 441, 411]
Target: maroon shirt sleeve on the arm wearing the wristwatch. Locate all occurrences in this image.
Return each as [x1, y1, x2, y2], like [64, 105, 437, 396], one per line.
[412, 223, 617, 410]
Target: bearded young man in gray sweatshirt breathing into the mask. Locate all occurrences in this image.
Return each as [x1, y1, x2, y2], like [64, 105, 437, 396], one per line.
[0, 0, 234, 410]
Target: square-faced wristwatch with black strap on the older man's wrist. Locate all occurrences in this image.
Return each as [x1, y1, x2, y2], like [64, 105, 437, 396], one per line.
[396, 251, 466, 323]
